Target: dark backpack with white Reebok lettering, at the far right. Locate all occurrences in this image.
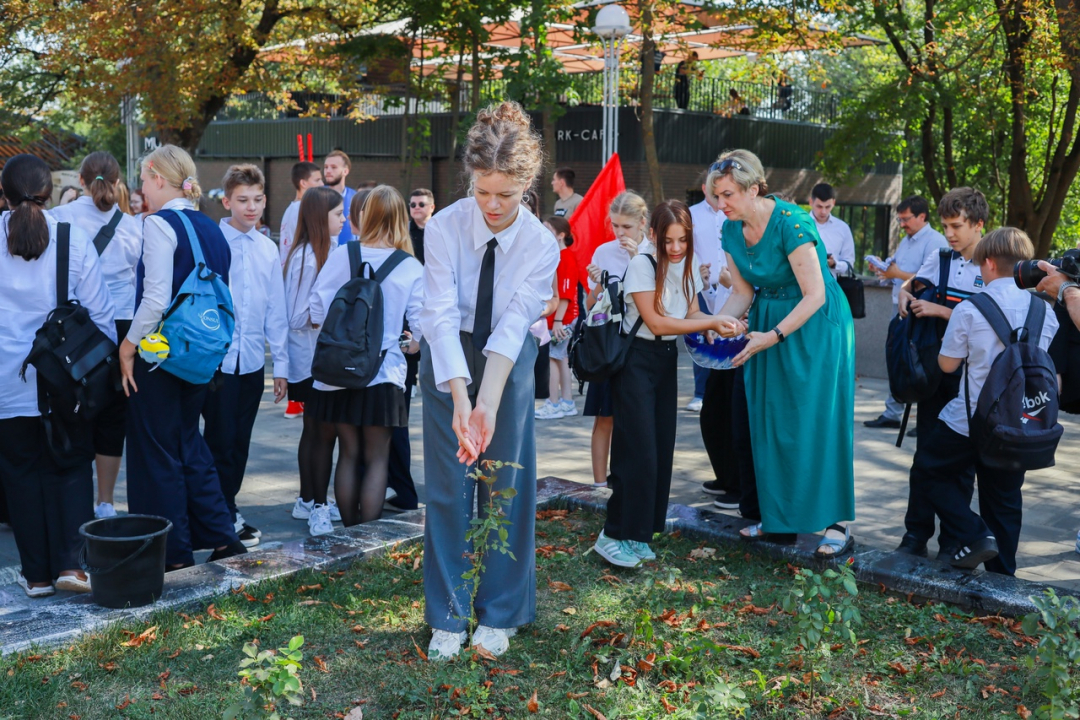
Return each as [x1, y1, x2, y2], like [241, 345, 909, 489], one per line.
[963, 294, 1063, 471]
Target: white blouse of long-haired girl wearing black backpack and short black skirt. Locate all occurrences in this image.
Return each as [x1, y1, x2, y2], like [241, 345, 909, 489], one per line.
[311, 245, 423, 390]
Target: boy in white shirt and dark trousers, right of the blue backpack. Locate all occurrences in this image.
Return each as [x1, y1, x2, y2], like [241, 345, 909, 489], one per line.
[202, 164, 288, 547]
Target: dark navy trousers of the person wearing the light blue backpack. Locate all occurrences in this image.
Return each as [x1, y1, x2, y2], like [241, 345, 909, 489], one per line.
[126, 357, 237, 565]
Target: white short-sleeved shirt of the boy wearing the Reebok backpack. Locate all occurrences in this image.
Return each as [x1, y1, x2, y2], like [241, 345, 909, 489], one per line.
[937, 277, 1057, 436]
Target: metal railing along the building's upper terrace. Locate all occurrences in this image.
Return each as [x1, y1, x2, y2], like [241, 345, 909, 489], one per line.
[215, 72, 839, 125]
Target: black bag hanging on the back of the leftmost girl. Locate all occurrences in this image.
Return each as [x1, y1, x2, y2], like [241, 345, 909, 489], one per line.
[18, 222, 120, 462]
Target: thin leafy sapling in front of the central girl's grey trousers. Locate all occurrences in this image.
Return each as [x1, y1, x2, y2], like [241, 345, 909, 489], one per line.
[461, 460, 522, 626]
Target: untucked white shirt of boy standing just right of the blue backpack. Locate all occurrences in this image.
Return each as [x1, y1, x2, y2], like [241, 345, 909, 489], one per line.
[220, 218, 288, 378]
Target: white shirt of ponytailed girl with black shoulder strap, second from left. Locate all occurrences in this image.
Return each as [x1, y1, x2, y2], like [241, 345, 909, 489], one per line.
[50, 195, 143, 320]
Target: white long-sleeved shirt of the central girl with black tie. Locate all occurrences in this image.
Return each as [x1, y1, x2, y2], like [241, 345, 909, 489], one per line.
[420, 198, 558, 392]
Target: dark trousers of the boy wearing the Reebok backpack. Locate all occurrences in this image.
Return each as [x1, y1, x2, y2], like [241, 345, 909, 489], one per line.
[912, 420, 1024, 575]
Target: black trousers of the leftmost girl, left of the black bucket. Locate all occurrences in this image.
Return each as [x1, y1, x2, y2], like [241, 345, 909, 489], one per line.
[0, 417, 94, 583]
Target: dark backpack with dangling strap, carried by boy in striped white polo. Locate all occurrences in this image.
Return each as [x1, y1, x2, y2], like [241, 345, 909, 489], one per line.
[885, 249, 953, 448]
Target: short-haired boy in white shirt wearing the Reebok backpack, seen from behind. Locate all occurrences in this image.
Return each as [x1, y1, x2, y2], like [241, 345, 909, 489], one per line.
[912, 228, 1057, 575]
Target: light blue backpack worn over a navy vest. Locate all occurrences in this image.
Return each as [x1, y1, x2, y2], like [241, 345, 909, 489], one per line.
[158, 210, 237, 385]
